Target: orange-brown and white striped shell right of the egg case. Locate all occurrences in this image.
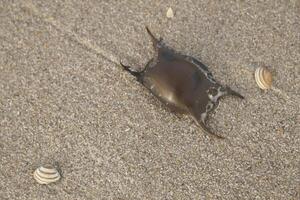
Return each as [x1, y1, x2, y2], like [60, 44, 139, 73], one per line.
[254, 67, 272, 90]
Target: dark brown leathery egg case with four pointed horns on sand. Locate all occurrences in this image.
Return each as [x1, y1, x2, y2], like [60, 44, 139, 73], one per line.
[121, 27, 244, 138]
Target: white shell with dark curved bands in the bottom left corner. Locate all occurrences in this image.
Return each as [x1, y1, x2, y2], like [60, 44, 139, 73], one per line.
[33, 166, 61, 184]
